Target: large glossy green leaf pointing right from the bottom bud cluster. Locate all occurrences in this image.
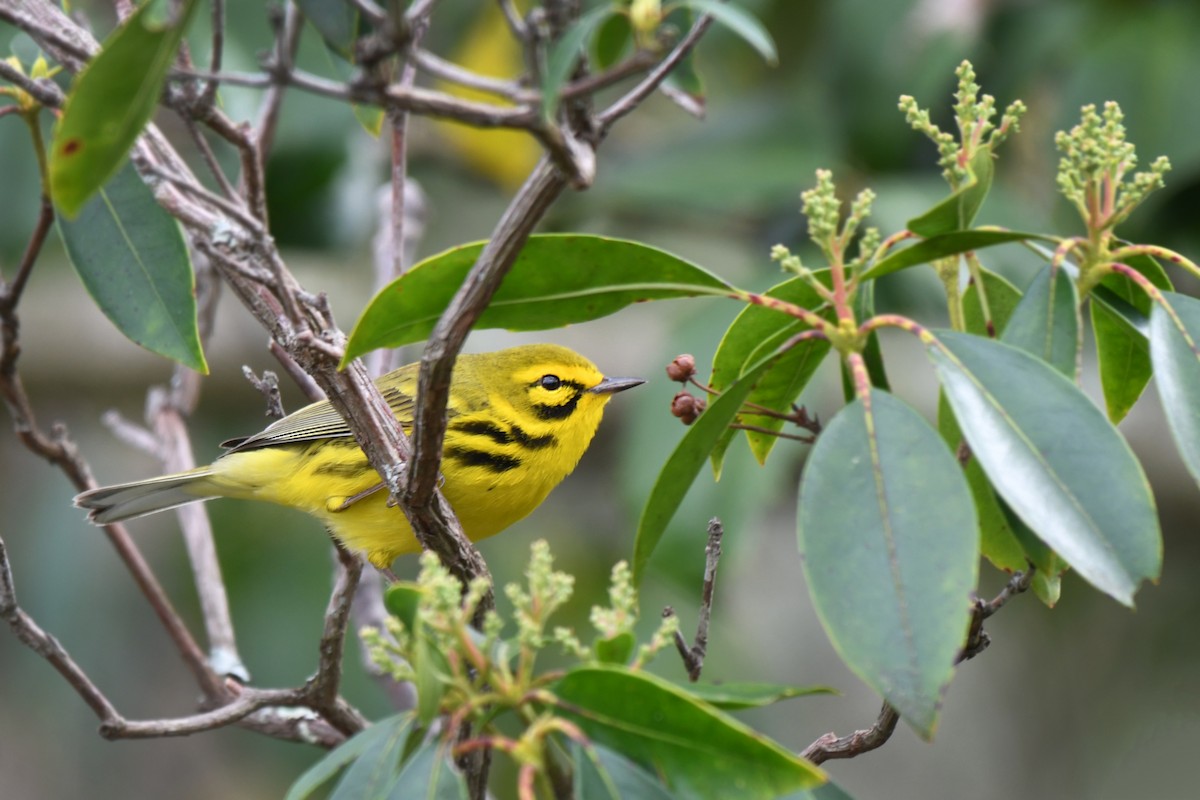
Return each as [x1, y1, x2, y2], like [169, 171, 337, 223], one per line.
[551, 666, 824, 800]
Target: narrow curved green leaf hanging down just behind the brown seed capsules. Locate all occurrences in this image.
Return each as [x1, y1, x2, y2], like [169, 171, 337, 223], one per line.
[634, 355, 775, 585]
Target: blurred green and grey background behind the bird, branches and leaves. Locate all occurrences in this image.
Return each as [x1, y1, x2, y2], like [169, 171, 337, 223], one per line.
[0, 0, 1200, 800]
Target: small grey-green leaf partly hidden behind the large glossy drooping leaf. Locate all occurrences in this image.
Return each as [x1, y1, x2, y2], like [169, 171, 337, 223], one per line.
[1001, 264, 1082, 380]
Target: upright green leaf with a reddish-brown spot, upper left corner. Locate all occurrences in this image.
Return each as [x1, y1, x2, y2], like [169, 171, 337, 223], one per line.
[49, 0, 196, 217]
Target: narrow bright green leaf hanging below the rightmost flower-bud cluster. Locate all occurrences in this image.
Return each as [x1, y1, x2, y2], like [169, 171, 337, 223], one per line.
[1091, 255, 1172, 425]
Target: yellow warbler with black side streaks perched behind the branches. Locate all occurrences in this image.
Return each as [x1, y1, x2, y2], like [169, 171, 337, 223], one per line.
[74, 344, 644, 567]
